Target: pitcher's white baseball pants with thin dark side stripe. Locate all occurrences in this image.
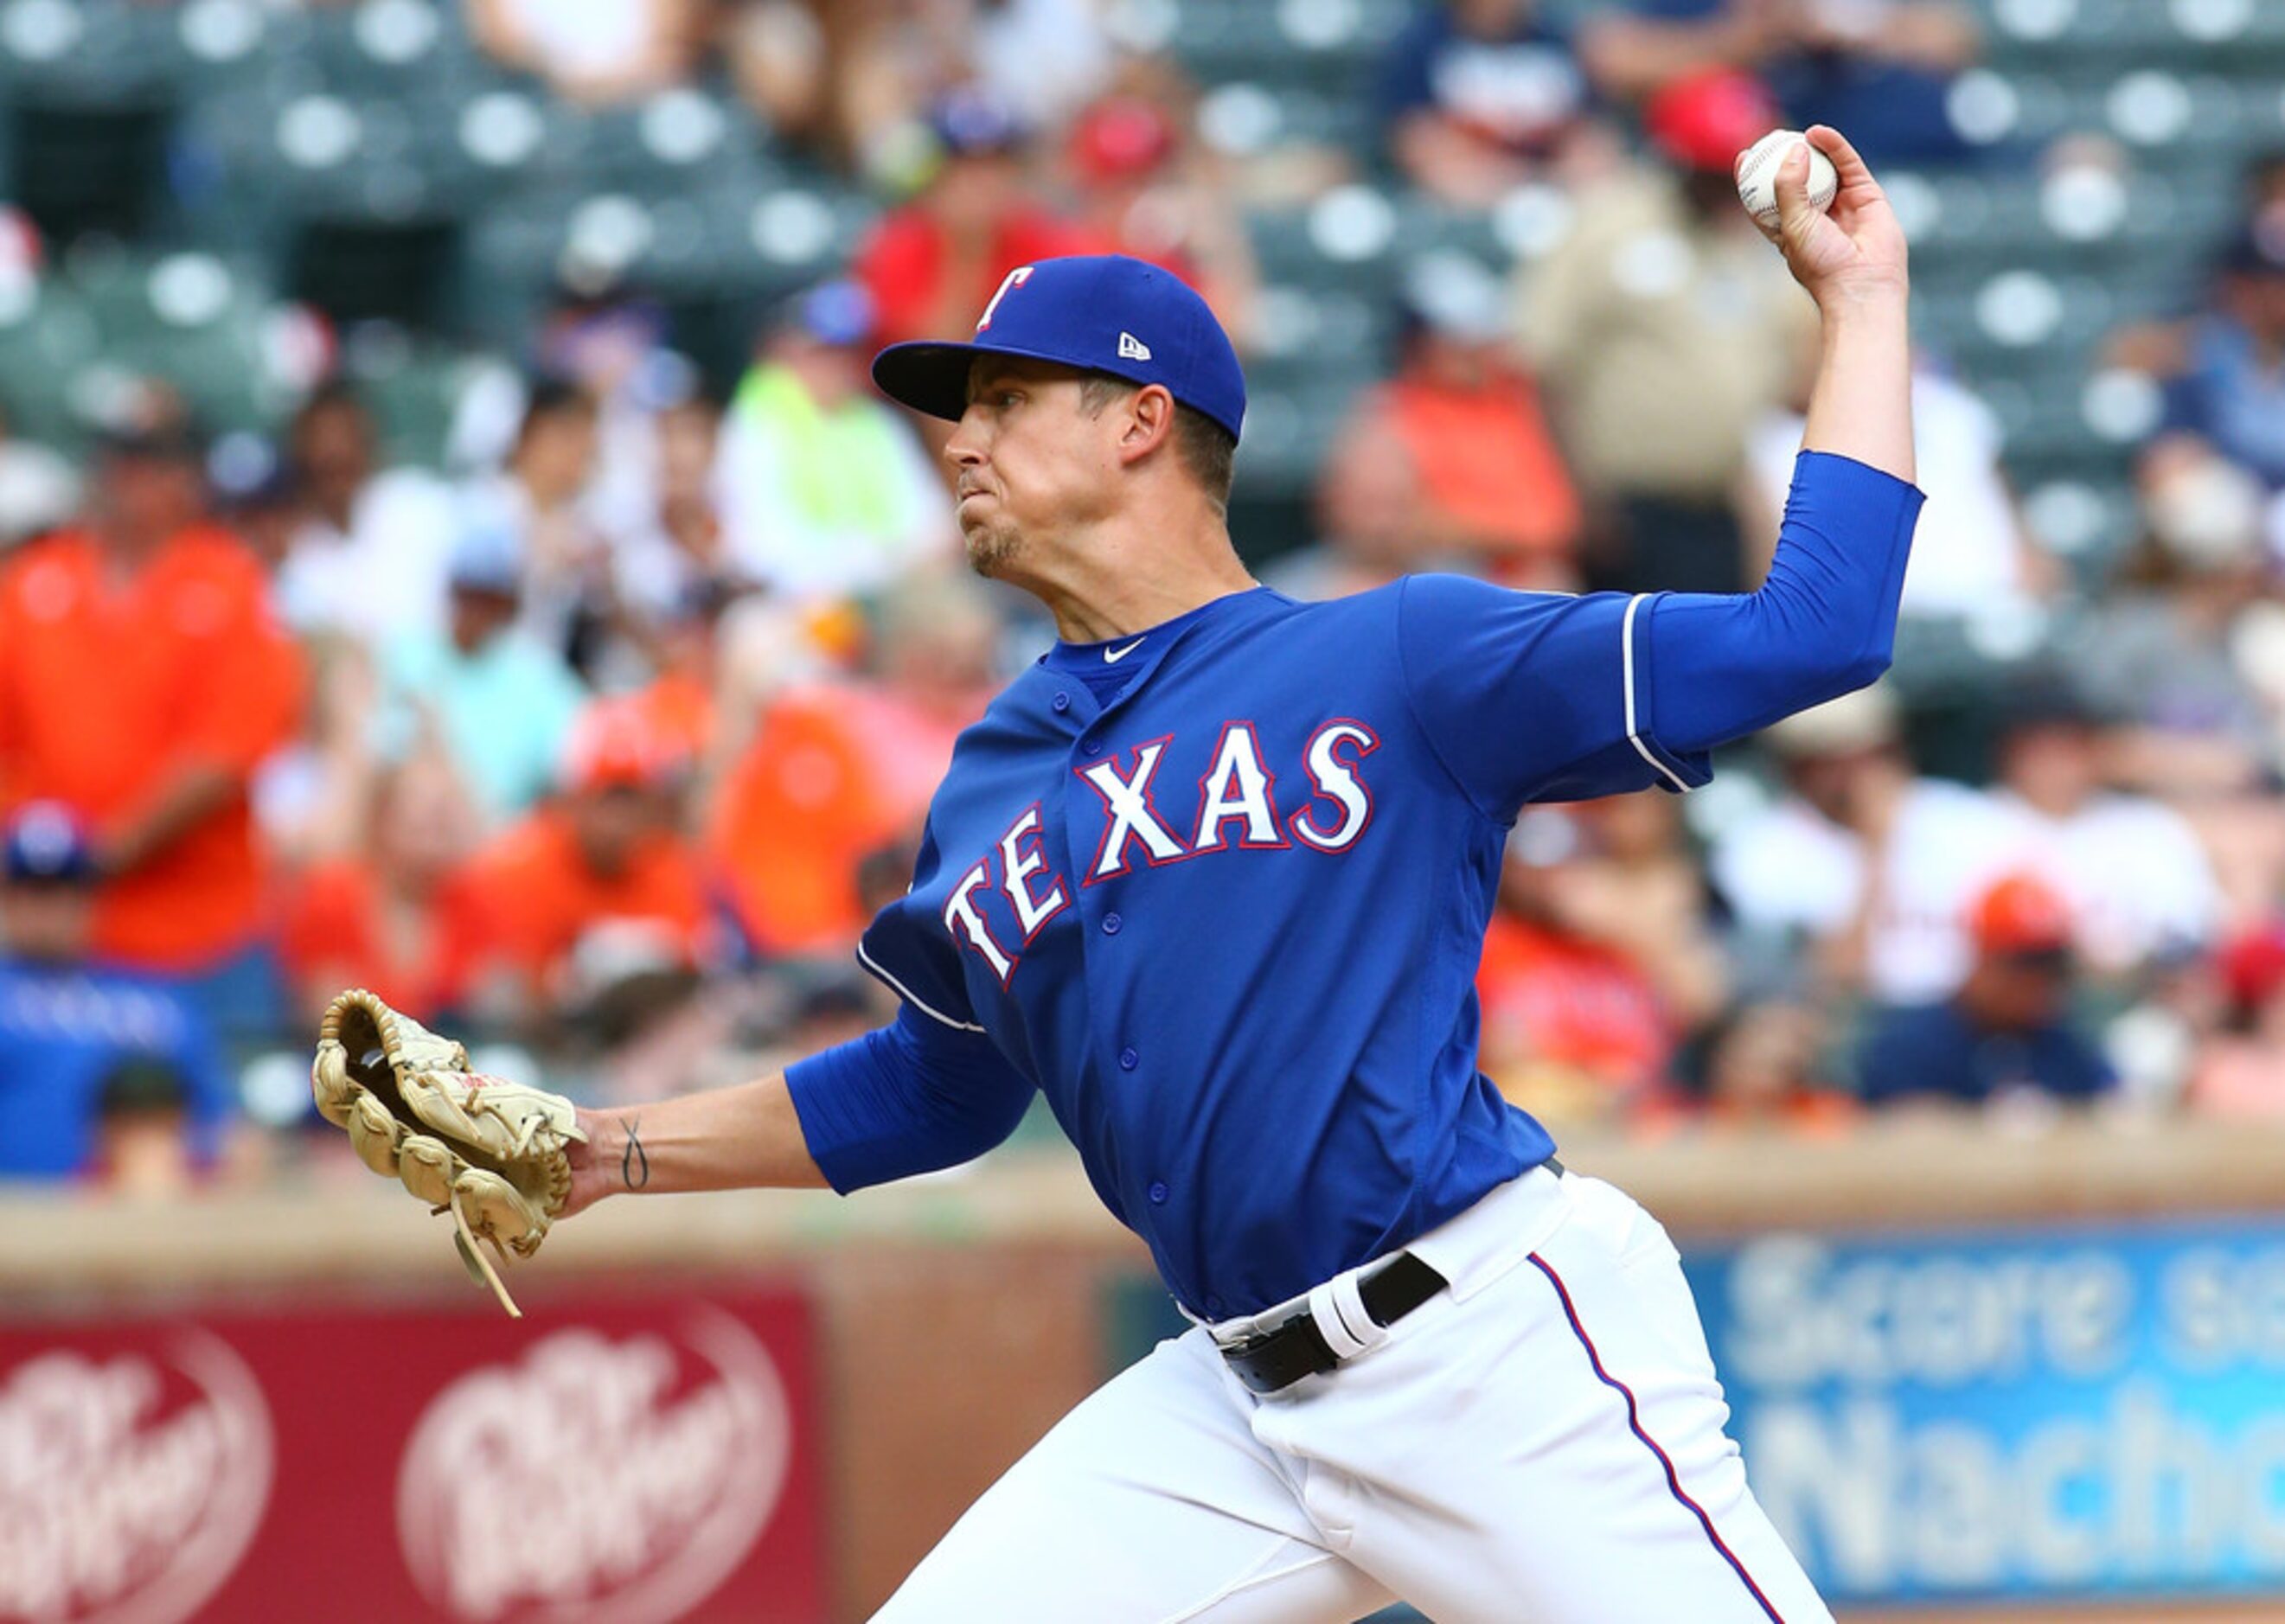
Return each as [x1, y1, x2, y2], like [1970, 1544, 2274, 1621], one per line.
[875, 1169, 1833, 1624]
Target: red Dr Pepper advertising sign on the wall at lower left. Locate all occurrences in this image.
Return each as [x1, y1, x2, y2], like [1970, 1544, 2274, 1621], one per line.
[0, 1293, 825, 1624]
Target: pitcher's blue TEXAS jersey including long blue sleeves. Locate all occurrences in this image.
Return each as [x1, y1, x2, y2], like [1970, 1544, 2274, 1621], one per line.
[788, 459, 1917, 1318]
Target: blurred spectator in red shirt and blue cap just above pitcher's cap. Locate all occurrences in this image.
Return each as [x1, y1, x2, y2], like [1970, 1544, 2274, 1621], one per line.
[854, 86, 1106, 356]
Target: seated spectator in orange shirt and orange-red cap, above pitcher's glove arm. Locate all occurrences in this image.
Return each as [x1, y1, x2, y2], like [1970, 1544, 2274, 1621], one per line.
[470, 699, 711, 1016]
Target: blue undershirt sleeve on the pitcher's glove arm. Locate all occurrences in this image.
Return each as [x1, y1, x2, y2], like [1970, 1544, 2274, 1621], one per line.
[786, 1005, 1033, 1194]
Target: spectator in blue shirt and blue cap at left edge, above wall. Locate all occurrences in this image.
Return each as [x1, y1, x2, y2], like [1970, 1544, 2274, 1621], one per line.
[0, 802, 235, 1188]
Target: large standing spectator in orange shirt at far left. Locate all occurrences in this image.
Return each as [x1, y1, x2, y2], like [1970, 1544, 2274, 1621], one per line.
[0, 425, 304, 1033]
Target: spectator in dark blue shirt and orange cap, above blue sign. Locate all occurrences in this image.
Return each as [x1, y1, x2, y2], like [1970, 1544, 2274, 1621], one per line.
[1858, 875, 2115, 1105]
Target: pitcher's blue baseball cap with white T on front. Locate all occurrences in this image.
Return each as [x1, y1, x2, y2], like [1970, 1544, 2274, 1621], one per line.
[873, 253, 1245, 438]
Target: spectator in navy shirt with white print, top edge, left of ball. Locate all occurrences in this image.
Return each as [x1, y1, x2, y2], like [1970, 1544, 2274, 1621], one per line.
[1380, 0, 1588, 208]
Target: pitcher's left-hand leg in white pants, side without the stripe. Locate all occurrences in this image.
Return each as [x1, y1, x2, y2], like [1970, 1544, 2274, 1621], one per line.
[875, 1332, 1392, 1624]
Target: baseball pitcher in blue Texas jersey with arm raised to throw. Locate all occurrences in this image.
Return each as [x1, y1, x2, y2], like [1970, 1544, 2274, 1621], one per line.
[320, 125, 1919, 1624]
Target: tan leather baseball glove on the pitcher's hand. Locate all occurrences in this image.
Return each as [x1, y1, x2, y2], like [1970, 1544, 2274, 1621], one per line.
[310, 987, 587, 1318]
